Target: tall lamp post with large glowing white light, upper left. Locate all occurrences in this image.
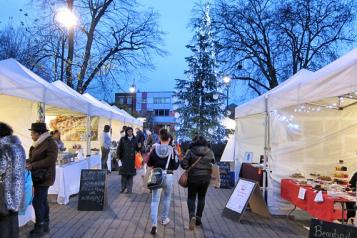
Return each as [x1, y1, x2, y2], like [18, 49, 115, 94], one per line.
[54, 7, 78, 81]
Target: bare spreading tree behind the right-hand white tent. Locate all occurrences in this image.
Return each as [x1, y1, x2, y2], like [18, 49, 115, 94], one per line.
[214, 0, 355, 95]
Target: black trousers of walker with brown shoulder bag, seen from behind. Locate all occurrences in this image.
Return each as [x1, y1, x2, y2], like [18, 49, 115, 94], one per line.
[187, 181, 210, 220]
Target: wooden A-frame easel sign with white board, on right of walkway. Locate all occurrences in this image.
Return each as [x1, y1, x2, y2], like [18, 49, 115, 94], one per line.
[223, 178, 271, 222]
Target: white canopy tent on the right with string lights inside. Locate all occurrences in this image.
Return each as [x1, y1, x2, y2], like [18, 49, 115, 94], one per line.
[235, 49, 357, 213]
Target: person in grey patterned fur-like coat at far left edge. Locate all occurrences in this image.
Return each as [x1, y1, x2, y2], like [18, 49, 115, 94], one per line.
[0, 122, 26, 238]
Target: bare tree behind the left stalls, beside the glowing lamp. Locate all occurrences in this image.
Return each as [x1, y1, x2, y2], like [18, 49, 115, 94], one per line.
[3, 0, 165, 93]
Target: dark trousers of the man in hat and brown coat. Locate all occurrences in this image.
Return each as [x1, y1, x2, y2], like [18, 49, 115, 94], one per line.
[32, 186, 50, 224]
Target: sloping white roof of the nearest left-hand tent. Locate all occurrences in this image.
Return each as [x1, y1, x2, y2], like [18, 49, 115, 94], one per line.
[0, 59, 85, 113]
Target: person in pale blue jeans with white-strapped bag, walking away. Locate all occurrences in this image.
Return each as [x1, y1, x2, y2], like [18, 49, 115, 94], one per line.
[147, 129, 179, 235]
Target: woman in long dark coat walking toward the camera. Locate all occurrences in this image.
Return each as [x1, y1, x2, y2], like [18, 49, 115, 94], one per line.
[117, 127, 139, 193]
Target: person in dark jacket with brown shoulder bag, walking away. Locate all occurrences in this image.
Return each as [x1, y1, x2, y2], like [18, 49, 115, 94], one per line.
[181, 136, 215, 230]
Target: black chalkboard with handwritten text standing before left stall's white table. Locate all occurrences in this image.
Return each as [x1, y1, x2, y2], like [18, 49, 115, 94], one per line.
[78, 169, 107, 211]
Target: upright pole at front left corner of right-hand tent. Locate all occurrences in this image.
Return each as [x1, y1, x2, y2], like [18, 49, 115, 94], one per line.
[263, 96, 270, 201]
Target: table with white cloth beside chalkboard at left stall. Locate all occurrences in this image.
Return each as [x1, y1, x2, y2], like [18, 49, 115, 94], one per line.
[48, 159, 89, 204]
